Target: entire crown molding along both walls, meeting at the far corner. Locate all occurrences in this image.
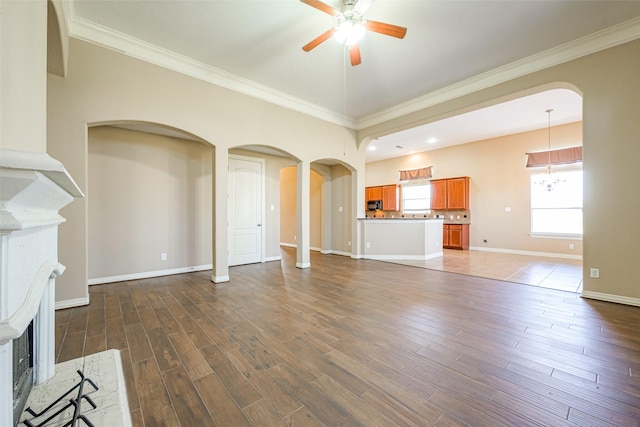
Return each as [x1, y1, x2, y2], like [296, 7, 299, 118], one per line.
[63, 4, 640, 130]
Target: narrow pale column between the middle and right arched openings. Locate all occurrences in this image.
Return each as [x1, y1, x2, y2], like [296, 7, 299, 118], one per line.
[296, 162, 311, 268]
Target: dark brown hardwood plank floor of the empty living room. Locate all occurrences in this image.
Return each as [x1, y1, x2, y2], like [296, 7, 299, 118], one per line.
[56, 249, 640, 427]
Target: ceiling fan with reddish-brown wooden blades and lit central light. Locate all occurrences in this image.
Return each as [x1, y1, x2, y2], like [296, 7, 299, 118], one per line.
[300, 0, 407, 66]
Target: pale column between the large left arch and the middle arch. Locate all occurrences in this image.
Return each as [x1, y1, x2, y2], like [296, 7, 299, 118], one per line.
[211, 147, 229, 283]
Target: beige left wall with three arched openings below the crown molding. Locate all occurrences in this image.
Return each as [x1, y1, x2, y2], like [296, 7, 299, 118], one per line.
[47, 39, 364, 302]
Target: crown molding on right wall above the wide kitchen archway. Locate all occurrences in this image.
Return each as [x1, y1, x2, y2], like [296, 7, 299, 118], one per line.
[356, 18, 640, 130]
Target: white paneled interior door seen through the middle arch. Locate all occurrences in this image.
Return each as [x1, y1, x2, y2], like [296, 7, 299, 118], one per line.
[229, 156, 264, 266]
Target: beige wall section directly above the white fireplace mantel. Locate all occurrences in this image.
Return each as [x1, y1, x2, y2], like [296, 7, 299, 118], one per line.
[0, 1, 47, 153]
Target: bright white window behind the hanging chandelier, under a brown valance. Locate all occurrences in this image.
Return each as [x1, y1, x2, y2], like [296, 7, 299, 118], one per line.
[531, 170, 582, 237]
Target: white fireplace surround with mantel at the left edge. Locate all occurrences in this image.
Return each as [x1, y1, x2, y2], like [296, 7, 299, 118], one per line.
[0, 149, 84, 426]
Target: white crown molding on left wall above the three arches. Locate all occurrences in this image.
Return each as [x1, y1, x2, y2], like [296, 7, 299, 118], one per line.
[67, 14, 355, 129]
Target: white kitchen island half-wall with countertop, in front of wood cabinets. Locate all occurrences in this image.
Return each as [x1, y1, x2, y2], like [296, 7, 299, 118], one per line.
[358, 218, 444, 261]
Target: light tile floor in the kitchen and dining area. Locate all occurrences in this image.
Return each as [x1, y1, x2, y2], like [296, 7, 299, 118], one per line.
[391, 249, 582, 292]
